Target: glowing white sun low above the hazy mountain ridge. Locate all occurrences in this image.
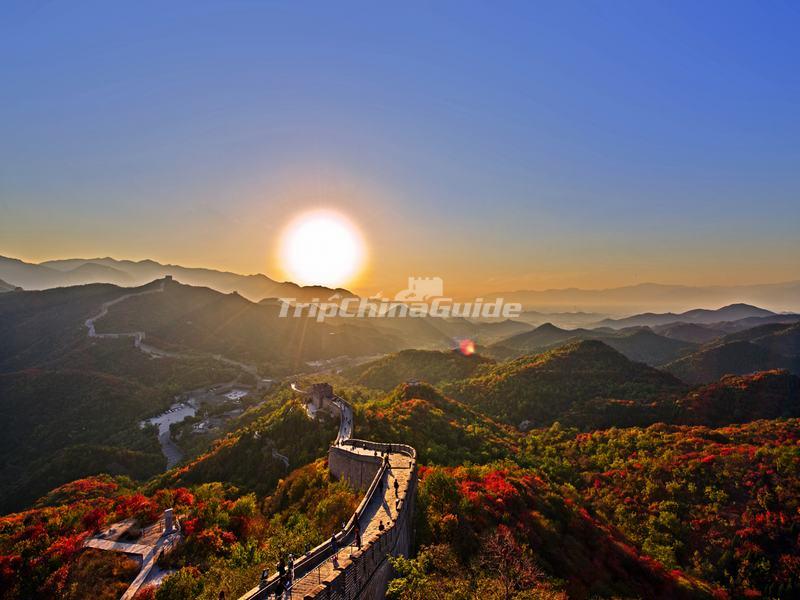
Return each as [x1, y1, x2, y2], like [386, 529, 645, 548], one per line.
[280, 210, 365, 287]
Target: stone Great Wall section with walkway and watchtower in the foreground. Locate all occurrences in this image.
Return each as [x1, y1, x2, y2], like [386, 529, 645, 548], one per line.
[240, 383, 417, 600]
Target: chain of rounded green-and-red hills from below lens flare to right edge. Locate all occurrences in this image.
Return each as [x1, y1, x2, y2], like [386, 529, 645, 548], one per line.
[342, 340, 800, 435]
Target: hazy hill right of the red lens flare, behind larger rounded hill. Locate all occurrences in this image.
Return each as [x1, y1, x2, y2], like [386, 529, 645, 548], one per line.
[495, 323, 697, 366]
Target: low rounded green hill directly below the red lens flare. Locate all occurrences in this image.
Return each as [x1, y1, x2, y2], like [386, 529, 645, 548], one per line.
[342, 350, 494, 391]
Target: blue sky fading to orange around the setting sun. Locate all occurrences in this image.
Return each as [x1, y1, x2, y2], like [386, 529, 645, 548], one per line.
[0, 1, 800, 293]
